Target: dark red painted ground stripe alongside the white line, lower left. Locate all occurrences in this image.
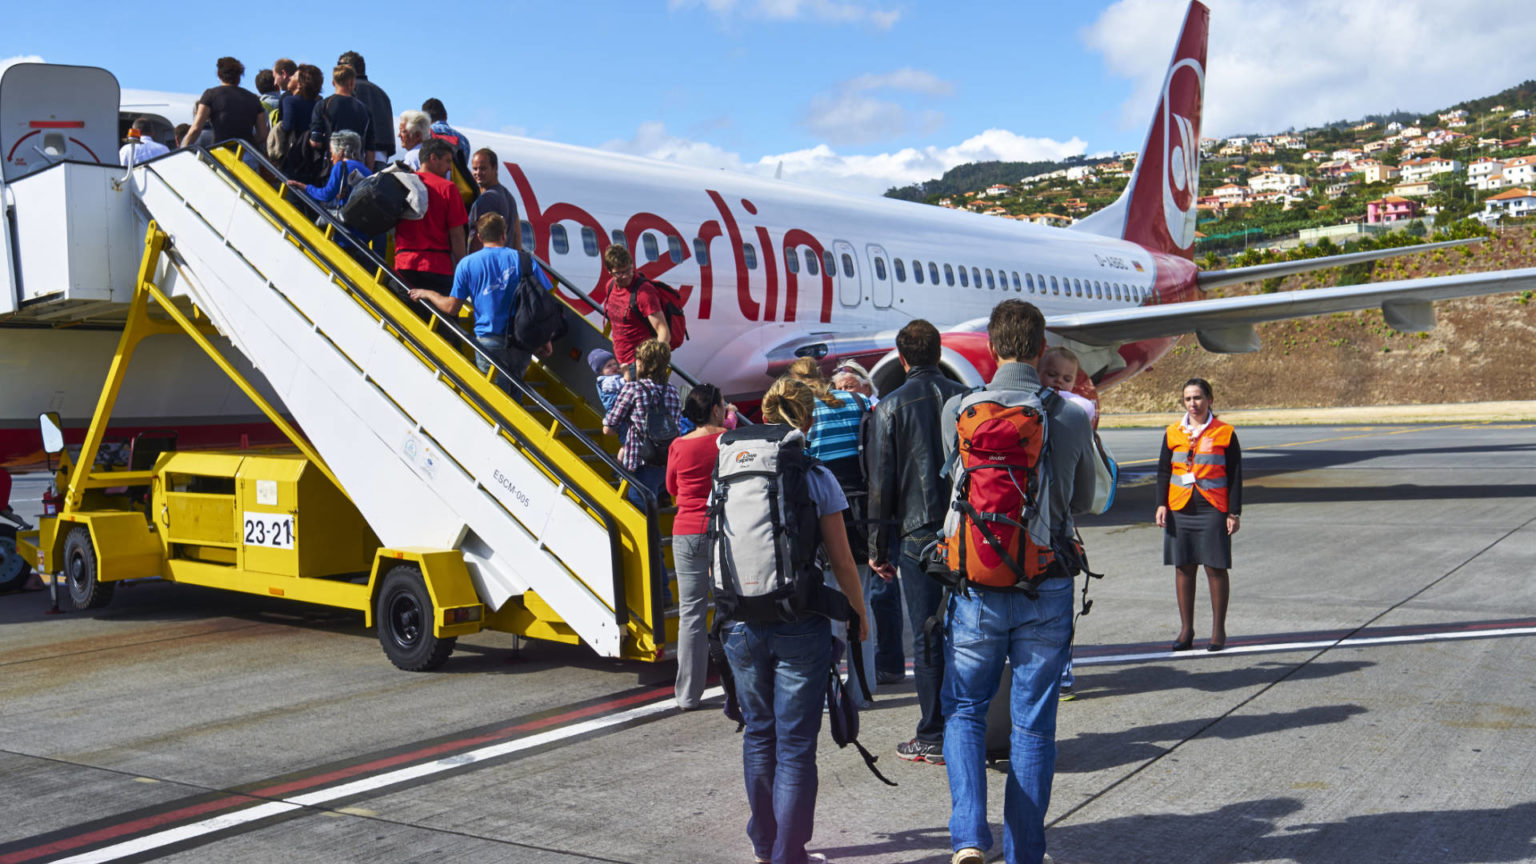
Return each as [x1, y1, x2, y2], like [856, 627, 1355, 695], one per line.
[0, 687, 673, 864]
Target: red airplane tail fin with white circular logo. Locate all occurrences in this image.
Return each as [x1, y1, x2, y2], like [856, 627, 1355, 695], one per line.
[1123, 2, 1210, 258]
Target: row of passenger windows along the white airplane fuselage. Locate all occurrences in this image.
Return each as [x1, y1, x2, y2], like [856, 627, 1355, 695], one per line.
[521, 220, 1147, 303]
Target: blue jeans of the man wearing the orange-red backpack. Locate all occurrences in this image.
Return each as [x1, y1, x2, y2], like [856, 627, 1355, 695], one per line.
[945, 580, 1072, 864]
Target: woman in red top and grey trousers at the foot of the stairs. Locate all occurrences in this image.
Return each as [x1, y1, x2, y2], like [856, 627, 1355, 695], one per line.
[667, 384, 730, 710]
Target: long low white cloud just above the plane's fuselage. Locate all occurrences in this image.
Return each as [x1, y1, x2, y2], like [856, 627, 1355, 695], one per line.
[592, 123, 1086, 194]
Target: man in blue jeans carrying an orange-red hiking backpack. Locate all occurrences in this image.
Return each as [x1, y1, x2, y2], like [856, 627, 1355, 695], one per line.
[934, 300, 1094, 864]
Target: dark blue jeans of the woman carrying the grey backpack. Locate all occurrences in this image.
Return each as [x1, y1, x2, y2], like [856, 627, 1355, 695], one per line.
[725, 615, 833, 864]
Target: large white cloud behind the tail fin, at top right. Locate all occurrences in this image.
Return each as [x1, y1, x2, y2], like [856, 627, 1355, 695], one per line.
[1081, 0, 1536, 135]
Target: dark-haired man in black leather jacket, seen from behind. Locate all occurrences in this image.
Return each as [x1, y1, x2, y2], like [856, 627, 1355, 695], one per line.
[868, 318, 966, 764]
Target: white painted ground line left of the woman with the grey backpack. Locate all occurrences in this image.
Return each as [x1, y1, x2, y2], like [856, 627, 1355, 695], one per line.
[55, 687, 725, 864]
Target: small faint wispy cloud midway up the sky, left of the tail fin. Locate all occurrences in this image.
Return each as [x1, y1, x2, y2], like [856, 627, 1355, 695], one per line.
[802, 69, 954, 145]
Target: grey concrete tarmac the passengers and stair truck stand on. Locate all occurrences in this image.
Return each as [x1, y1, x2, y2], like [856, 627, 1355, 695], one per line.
[0, 414, 1536, 864]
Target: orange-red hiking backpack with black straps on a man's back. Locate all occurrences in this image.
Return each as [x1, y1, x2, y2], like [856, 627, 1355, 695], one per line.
[937, 390, 1058, 595]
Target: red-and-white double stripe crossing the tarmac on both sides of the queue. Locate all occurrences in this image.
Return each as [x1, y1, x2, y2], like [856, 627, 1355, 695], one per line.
[0, 618, 1536, 864]
